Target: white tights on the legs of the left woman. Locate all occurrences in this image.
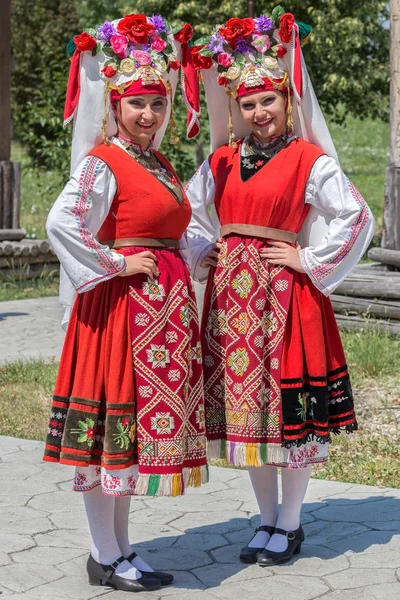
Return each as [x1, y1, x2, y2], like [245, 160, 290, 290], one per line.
[83, 486, 152, 579]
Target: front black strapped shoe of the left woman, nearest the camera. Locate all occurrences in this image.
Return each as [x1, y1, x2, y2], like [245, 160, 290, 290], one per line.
[86, 555, 161, 592]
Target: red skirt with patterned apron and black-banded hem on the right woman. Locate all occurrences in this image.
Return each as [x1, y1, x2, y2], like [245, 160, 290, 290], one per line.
[202, 235, 357, 466]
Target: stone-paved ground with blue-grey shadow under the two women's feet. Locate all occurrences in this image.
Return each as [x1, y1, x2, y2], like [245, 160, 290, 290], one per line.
[0, 437, 400, 600]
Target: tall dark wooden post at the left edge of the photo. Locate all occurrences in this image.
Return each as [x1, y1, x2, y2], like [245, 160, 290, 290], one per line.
[0, 0, 26, 241]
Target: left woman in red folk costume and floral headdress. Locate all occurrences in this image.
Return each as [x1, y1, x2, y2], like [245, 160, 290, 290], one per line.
[44, 14, 207, 592]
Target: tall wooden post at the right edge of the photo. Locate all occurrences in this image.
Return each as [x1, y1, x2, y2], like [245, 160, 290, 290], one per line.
[382, 0, 400, 250]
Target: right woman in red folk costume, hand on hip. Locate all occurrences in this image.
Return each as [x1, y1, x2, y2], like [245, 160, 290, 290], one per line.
[186, 7, 374, 566]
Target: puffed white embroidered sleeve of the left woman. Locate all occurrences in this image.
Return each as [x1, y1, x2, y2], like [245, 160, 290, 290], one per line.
[46, 156, 126, 293]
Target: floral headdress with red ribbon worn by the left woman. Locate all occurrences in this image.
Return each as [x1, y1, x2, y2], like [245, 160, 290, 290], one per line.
[64, 14, 198, 143]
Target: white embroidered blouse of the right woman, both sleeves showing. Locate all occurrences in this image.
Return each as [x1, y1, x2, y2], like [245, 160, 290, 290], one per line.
[185, 143, 374, 296]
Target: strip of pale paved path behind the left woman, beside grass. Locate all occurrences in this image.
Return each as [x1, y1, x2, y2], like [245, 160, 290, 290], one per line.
[0, 298, 64, 364]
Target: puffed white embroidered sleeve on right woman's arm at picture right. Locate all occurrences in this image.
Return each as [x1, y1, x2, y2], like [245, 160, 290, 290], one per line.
[300, 156, 374, 296]
